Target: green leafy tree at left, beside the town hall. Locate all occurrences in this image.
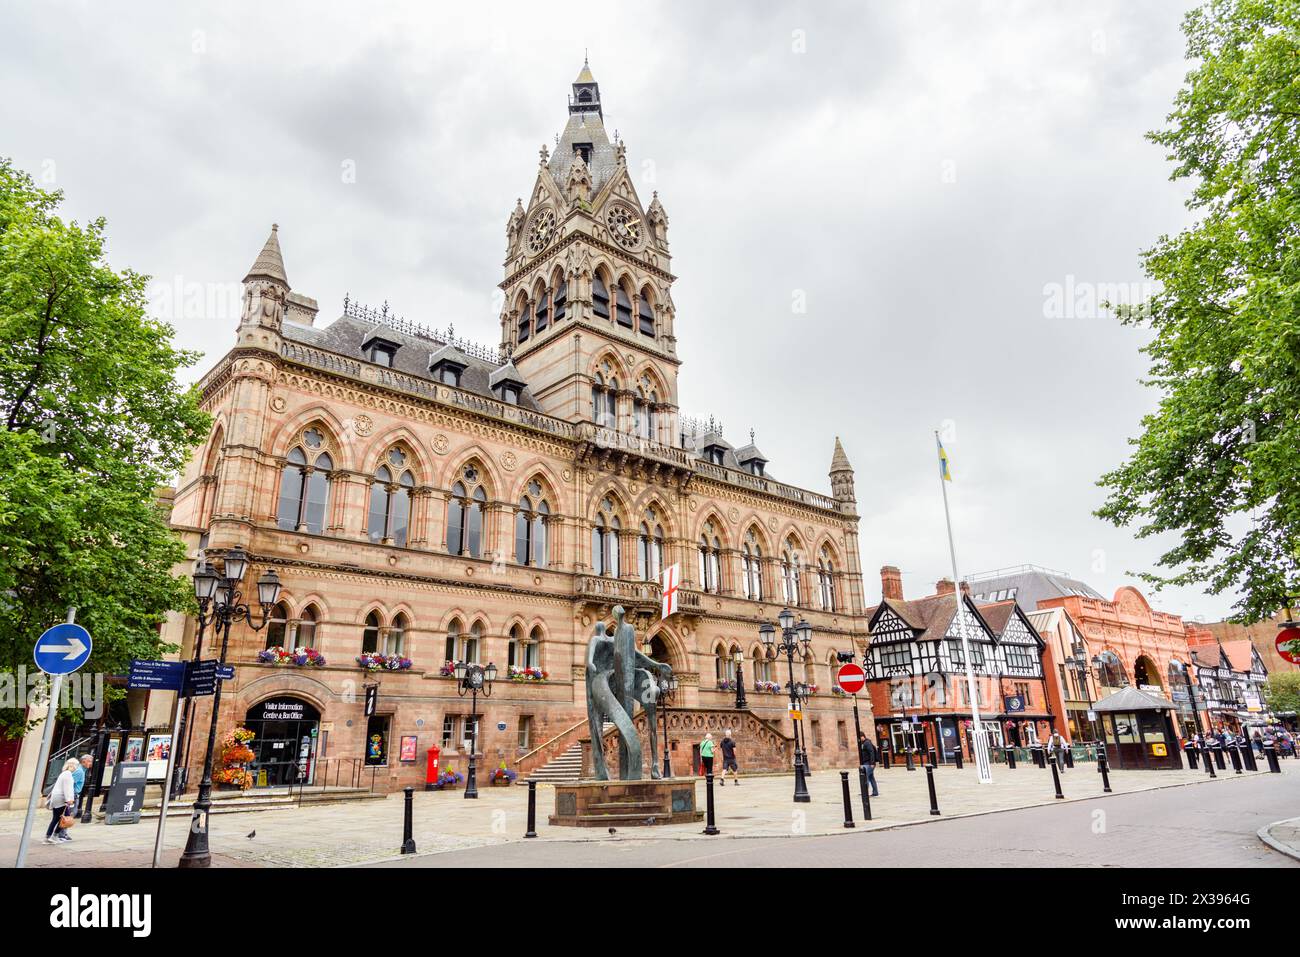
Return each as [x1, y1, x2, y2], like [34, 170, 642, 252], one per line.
[0, 159, 209, 736]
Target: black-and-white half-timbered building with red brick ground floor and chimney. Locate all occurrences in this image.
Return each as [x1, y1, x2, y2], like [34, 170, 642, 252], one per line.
[865, 566, 1056, 761]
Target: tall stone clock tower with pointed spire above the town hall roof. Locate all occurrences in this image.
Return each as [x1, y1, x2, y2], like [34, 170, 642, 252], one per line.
[501, 55, 680, 436]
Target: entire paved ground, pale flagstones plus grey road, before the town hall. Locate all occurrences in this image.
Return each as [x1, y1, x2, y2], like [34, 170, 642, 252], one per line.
[0, 761, 1300, 867]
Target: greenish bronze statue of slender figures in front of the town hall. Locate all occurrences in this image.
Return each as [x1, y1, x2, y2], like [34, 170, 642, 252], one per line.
[586, 605, 672, 781]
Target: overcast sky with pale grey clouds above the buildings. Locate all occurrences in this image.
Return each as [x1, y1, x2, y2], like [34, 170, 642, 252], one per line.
[0, 0, 1232, 620]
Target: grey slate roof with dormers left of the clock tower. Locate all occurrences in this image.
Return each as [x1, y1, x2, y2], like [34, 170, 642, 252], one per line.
[282, 315, 541, 412]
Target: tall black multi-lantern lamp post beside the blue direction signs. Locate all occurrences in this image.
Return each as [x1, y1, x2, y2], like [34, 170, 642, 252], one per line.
[173, 545, 280, 867]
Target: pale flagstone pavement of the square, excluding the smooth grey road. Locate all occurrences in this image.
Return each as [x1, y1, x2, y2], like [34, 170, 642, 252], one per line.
[0, 762, 1284, 867]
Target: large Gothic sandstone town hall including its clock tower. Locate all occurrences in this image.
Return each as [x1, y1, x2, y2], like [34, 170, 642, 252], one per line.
[162, 66, 867, 788]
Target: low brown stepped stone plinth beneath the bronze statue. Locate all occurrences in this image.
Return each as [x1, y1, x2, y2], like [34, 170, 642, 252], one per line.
[550, 778, 705, 827]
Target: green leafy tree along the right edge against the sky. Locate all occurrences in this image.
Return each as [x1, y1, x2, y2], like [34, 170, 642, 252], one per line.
[1097, 0, 1300, 622]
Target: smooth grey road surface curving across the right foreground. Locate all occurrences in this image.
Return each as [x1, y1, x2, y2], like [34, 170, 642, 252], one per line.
[371, 772, 1300, 869]
